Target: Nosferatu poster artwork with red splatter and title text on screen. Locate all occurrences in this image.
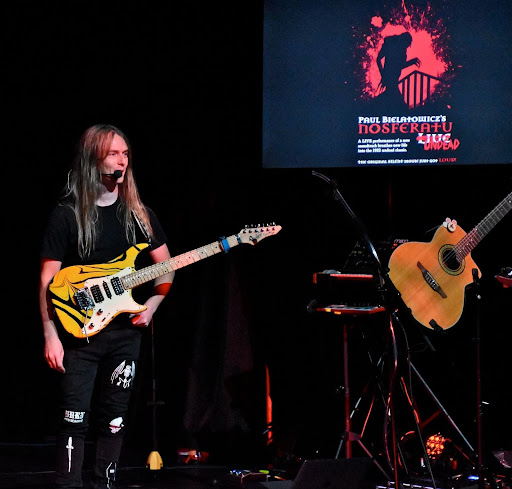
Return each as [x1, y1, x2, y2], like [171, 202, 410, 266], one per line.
[354, 1, 463, 165]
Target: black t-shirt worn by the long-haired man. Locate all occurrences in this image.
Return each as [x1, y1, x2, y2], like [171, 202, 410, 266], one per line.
[41, 198, 167, 268]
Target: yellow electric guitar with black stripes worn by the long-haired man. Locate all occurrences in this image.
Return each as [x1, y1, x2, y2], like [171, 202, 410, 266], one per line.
[49, 224, 281, 338]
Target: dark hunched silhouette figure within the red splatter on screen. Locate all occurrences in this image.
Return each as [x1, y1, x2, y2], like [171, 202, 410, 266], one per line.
[377, 32, 421, 104]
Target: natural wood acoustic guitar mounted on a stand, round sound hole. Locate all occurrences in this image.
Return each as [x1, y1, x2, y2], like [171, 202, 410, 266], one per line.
[389, 193, 512, 330]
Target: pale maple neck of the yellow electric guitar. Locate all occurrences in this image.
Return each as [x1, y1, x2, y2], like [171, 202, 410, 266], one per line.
[121, 234, 240, 289]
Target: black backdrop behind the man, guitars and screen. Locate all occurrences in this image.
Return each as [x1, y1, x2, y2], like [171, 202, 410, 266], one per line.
[0, 1, 512, 472]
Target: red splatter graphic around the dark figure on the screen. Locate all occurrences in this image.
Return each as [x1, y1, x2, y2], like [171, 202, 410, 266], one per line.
[354, 2, 453, 107]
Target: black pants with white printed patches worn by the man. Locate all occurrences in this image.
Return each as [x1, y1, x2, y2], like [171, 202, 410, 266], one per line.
[56, 324, 141, 488]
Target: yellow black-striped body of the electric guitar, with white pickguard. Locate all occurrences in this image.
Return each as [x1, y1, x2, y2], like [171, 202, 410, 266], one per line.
[49, 243, 148, 338]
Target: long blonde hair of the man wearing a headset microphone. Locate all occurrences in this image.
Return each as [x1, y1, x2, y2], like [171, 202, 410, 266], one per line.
[65, 124, 153, 258]
